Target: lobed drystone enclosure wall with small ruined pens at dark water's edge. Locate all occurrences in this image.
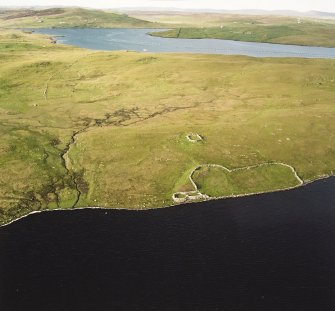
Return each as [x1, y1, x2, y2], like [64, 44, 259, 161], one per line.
[172, 162, 304, 203]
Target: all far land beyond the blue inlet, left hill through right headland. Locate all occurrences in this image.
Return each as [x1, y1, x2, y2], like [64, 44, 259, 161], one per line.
[0, 8, 335, 47]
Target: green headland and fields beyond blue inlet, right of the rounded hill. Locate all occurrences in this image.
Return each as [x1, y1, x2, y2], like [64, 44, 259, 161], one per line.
[139, 14, 335, 47]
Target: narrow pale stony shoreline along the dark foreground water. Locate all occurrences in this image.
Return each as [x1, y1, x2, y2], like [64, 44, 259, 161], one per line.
[0, 175, 334, 229]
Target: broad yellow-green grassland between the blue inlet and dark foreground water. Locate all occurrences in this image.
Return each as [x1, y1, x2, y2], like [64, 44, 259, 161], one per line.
[0, 31, 335, 223]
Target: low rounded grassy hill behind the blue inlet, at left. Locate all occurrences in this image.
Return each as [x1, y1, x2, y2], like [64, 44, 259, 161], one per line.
[0, 8, 159, 28]
